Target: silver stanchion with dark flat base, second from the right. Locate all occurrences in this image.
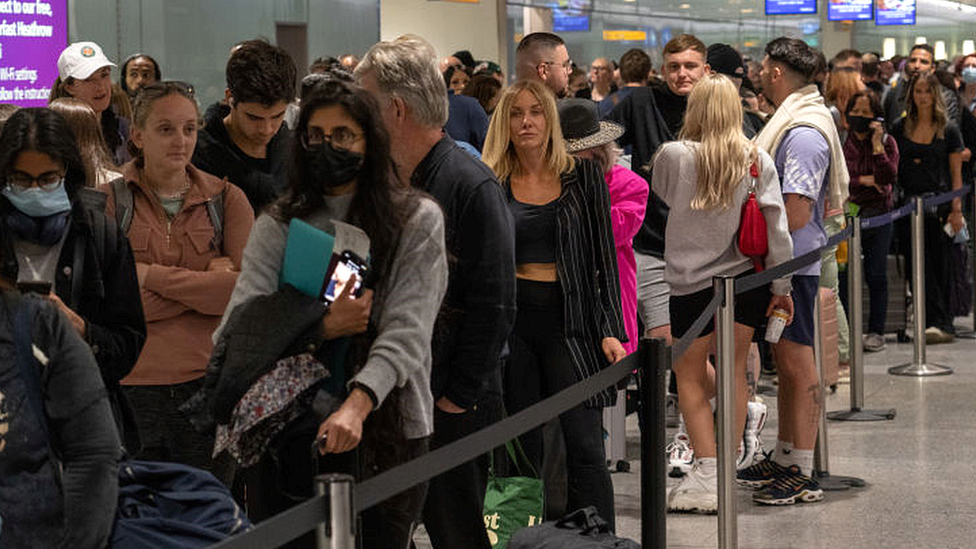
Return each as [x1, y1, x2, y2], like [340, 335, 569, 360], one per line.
[827, 217, 895, 421]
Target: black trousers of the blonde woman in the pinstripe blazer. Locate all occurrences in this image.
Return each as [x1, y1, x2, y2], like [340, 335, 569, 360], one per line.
[505, 279, 614, 528]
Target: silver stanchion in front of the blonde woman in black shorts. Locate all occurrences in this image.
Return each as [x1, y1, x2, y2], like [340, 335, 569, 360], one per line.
[713, 276, 742, 549]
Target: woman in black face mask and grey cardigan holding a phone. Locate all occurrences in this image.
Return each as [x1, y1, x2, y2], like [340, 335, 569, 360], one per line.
[217, 80, 447, 548]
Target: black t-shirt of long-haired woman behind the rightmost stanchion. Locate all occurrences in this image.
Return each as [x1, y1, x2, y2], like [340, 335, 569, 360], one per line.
[891, 119, 963, 196]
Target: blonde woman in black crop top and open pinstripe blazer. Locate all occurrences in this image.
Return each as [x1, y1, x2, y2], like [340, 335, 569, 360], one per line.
[484, 81, 627, 528]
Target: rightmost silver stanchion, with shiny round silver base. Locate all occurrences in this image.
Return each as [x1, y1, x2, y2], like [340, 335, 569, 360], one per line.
[888, 196, 952, 377]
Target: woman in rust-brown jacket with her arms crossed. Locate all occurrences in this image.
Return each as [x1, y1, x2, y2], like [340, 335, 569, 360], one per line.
[103, 82, 254, 482]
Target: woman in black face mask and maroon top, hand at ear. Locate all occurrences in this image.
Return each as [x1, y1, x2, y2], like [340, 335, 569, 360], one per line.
[841, 90, 898, 351]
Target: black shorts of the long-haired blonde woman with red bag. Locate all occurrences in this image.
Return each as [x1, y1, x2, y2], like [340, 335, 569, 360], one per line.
[670, 270, 772, 338]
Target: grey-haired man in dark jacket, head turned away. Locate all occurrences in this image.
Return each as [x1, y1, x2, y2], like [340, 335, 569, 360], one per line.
[356, 35, 515, 549]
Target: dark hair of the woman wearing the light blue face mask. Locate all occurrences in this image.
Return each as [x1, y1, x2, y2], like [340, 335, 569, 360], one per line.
[0, 108, 85, 201]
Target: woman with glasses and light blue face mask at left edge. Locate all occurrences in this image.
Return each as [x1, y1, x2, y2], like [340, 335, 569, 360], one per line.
[0, 109, 146, 452]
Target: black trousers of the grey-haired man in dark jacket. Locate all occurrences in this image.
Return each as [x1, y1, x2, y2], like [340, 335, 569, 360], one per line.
[424, 392, 502, 549]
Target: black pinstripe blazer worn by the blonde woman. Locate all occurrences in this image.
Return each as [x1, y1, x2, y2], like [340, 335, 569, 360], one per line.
[505, 159, 627, 407]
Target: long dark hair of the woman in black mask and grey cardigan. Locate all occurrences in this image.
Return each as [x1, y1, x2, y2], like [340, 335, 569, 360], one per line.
[271, 80, 418, 469]
